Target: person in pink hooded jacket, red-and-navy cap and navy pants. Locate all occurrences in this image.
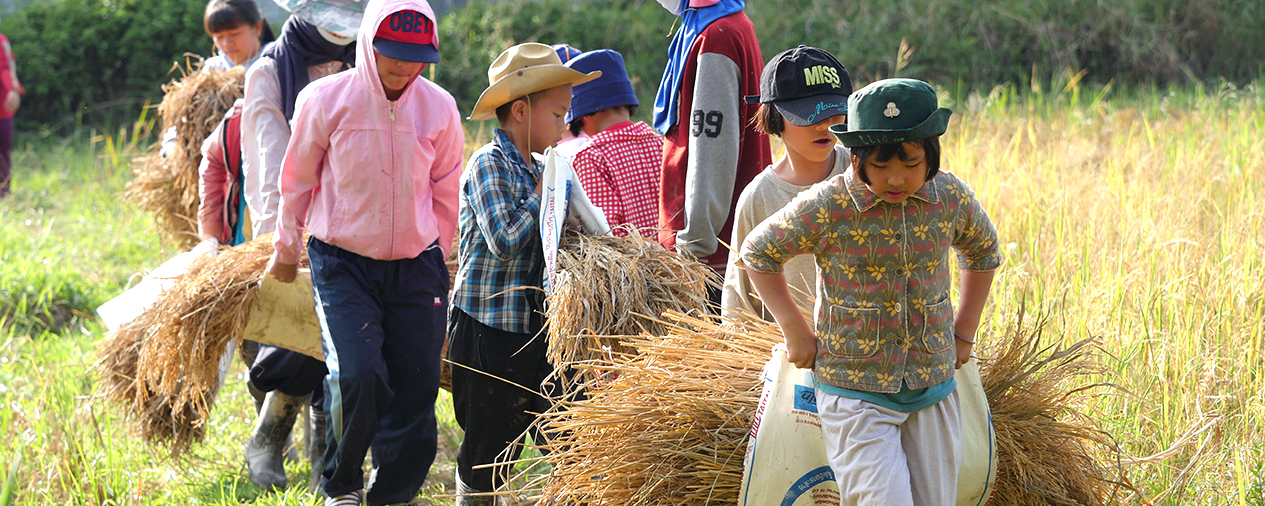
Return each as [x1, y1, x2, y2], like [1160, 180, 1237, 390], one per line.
[269, 0, 463, 505]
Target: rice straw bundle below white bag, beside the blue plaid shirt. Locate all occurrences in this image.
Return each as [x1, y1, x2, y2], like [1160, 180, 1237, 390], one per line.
[546, 228, 720, 381]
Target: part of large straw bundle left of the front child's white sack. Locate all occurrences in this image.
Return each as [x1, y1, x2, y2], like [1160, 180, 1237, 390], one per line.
[543, 314, 782, 506]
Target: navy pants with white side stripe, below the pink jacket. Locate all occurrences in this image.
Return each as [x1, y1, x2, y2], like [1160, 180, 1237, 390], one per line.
[307, 238, 448, 505]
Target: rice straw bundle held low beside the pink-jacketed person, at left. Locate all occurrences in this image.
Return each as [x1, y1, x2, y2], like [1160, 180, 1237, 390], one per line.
[97, 234, 307, 457]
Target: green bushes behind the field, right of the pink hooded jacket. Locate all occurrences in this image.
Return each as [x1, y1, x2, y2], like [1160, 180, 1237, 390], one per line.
[434, 0, 1265, 118]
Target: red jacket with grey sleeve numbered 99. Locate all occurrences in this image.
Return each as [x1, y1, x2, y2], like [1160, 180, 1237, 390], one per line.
[659, 13, 773, 276]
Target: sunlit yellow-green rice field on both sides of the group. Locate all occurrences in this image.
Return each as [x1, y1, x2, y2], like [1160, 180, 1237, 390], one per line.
[0, 76, 1265, 506]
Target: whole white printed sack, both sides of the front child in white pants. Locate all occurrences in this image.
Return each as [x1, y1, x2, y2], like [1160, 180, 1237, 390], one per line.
[737, 344, 997, 506]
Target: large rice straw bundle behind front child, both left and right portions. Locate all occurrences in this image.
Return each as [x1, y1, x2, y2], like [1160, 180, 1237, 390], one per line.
[531, 306, 1127, 506]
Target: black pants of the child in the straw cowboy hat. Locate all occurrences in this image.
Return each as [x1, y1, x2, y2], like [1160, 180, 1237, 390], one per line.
[448, 306, 558, 492]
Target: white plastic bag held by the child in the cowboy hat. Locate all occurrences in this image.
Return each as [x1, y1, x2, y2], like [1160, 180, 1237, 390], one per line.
[539, 149, 611, 293]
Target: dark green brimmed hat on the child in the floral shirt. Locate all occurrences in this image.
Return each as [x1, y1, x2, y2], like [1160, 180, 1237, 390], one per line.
[830, 78, 953, 148]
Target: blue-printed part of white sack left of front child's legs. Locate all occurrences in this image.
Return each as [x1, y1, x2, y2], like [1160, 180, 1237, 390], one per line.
[737, 344, 839, 506]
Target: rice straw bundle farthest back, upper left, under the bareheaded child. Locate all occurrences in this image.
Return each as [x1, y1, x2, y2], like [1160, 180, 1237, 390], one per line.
[127, 62, 245, 245]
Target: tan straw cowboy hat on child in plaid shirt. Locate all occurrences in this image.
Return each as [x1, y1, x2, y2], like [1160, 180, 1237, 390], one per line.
[467, 42, 602, 120]
